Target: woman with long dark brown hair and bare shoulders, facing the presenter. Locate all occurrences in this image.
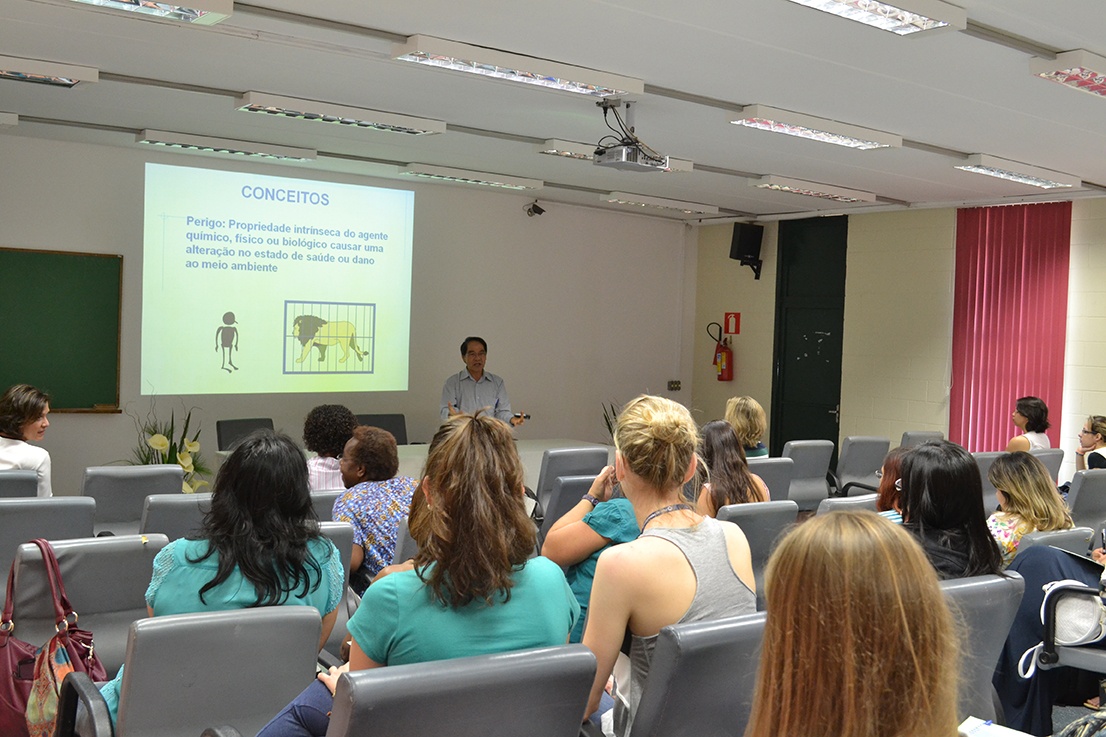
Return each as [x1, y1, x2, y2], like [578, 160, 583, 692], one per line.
[697, 419, 769, 517]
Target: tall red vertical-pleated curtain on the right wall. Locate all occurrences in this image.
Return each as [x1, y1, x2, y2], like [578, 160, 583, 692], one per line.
[949, 203, 1072, 451]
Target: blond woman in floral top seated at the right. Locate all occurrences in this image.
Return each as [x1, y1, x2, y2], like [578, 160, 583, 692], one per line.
[987, 450, 1073, 568]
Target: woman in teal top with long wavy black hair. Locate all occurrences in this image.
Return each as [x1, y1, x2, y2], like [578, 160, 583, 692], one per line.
[101, 430, 345, 723]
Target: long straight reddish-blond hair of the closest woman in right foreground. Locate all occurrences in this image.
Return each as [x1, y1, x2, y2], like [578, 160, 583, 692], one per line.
[745, 511, 959, 737]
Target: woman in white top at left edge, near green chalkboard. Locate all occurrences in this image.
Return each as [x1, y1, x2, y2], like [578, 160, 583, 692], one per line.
[0, 384, 53, 497]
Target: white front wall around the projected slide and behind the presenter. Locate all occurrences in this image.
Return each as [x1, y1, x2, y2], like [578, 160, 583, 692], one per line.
[0, 135, 695, 495]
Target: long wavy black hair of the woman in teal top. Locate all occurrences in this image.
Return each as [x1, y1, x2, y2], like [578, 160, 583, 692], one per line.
[192, 429, 324, 606]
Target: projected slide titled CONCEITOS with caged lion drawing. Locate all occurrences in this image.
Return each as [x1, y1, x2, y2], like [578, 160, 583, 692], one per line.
[142, 164, 415, 394]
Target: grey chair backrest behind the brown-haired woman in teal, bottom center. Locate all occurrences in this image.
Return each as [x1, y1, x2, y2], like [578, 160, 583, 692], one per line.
[326, 645, 595, 737]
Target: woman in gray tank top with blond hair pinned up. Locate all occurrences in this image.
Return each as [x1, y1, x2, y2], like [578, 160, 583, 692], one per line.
[583, 396, 757, 736]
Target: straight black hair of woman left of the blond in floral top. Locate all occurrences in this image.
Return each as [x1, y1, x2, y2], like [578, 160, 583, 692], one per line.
[899, 440, 1002, 575]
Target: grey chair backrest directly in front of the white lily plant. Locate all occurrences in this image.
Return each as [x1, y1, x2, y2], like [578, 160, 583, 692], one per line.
[81, 464, 185, 534]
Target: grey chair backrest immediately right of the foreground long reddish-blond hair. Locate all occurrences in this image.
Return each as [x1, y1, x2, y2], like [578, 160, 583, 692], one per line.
[941, 571, 1025, 719]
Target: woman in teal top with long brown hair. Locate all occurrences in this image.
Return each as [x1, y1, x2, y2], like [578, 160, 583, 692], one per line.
[258, 415, 580, 737]
